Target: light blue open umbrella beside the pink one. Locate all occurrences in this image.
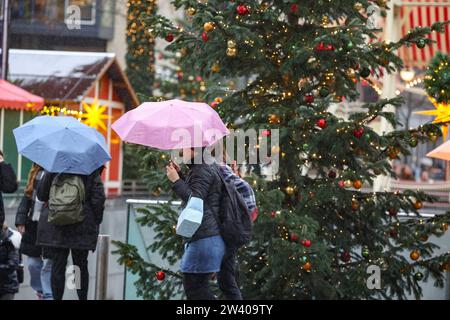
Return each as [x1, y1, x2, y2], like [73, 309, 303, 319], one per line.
[13, 116, 111, 175]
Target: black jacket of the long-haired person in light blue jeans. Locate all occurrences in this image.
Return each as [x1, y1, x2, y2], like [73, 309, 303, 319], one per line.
[16, 171, 43, 257]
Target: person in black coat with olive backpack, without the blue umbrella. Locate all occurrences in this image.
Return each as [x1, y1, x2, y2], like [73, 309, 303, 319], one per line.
[37, 167, 106, 300]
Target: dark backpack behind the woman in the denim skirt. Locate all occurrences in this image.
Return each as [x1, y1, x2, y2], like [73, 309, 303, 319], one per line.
[216, 167, 252, 247]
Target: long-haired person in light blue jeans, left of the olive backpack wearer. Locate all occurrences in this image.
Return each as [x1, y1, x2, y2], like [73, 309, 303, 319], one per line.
[16, 164, 53, 300]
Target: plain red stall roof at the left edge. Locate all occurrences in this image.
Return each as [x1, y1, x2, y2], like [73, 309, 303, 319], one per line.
[0, 79, 44, 111]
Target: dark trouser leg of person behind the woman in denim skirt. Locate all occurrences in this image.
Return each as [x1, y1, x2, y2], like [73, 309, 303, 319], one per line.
[217, 246, 242, 300]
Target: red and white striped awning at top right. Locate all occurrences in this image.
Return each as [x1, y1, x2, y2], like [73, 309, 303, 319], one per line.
[397, 0, 450, 68]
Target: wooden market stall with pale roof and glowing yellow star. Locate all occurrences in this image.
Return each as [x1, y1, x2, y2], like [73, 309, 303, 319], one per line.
[4, 49, 138, 196]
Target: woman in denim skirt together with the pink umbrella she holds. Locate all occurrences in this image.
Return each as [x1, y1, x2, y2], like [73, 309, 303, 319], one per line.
[112, 99, 232, 300]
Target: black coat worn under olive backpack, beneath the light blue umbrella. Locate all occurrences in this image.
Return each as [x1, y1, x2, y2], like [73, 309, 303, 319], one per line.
[37, 171, 106, 251]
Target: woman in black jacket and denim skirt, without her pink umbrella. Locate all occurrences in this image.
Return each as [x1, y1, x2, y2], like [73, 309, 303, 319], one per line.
[166, 148, 225, 300]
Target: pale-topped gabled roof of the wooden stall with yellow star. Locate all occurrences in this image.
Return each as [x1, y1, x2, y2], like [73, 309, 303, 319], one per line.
[9, 49, 139, 108]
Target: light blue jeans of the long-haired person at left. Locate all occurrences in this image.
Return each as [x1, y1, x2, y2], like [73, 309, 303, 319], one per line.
[28, 257, 53, 300]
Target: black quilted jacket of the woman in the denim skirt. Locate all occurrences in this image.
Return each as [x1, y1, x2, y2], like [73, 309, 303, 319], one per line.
[172, 163, 223, 242]
